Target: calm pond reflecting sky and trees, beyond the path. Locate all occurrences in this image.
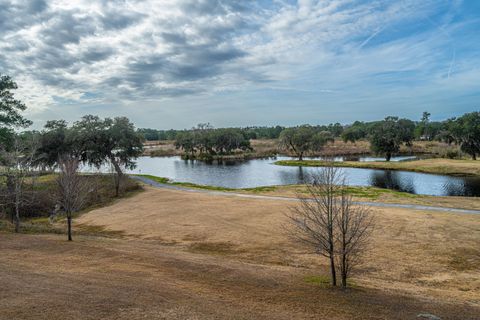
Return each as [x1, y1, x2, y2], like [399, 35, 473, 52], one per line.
[119, 157, 480, 196]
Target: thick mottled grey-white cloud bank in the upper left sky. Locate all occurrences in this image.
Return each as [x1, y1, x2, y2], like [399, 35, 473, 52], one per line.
[0, 0, 274, 103]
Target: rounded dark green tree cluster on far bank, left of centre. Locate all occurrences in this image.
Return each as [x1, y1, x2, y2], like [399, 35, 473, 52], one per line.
[175, 124, 251, 159]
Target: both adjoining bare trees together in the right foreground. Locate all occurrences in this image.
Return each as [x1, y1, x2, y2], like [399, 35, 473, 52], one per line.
[288, 166, 373, 288]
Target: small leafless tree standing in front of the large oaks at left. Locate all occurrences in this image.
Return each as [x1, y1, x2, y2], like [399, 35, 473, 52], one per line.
[57, 156, 88, 241]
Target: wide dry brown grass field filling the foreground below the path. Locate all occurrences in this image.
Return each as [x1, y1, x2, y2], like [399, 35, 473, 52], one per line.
[0, 188, 480, 320]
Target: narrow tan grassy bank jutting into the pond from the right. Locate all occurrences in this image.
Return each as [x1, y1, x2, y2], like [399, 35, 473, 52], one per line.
[275, 159, 480, 176]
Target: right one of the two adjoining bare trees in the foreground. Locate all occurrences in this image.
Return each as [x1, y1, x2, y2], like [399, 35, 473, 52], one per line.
[334, 188, 373, 288]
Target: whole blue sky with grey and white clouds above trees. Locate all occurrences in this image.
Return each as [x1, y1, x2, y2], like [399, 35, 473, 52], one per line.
[0, 0, 480, 129]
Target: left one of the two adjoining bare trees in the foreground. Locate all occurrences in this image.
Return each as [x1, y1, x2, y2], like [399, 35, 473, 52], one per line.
[288, 166, 344, 286]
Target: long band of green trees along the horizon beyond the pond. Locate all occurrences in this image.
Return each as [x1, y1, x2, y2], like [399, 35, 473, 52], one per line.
[147, 112, 480, 161]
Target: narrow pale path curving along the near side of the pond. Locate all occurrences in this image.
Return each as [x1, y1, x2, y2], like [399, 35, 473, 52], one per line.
[131, 176, 480, 214]
